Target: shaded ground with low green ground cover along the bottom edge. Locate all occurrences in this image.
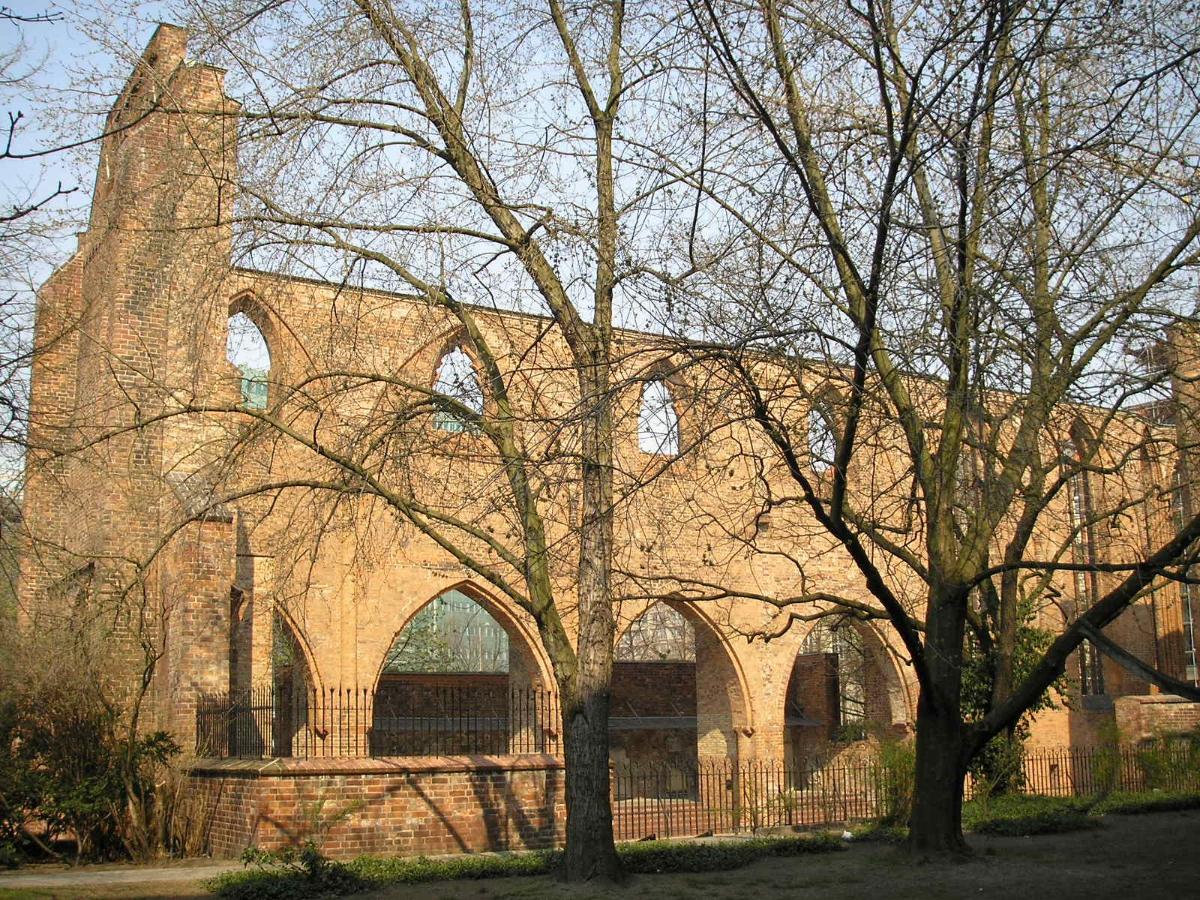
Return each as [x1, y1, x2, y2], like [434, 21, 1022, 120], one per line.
[0, 796, 1200, 900]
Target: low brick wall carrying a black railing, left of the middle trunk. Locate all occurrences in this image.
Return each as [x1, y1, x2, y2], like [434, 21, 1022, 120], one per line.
[188, 756, 566, 857]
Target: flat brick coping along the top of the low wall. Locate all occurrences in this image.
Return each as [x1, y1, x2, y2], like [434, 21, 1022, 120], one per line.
[187, 754, 565, 778]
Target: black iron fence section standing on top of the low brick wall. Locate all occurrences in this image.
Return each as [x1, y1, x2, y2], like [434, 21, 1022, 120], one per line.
[196, 685, 559, 760]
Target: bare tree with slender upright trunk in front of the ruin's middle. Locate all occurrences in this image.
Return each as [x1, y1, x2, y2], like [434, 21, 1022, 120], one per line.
[74, 0, 715, 880]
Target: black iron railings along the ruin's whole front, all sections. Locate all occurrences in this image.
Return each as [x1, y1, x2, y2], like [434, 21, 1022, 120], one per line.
[196, 684, 1200, 840]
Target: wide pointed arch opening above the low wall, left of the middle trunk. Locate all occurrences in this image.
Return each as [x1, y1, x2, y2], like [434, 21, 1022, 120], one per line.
[370, 590, 554, 756]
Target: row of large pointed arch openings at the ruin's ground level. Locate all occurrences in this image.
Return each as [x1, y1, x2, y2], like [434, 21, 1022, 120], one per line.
[232, 584, 907, 770]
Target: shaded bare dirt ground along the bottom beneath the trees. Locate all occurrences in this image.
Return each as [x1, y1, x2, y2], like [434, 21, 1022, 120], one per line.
[0, 811, 1200, 900]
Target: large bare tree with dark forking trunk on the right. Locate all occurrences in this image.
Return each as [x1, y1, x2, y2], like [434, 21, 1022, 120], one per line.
[666, 0, 1200, 853]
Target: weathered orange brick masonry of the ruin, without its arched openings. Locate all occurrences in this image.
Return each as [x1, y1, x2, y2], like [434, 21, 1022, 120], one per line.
[20, 25, 1200, 852]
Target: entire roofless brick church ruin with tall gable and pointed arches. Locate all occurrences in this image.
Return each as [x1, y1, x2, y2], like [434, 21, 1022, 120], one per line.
[20, 25, 1200, 853]
